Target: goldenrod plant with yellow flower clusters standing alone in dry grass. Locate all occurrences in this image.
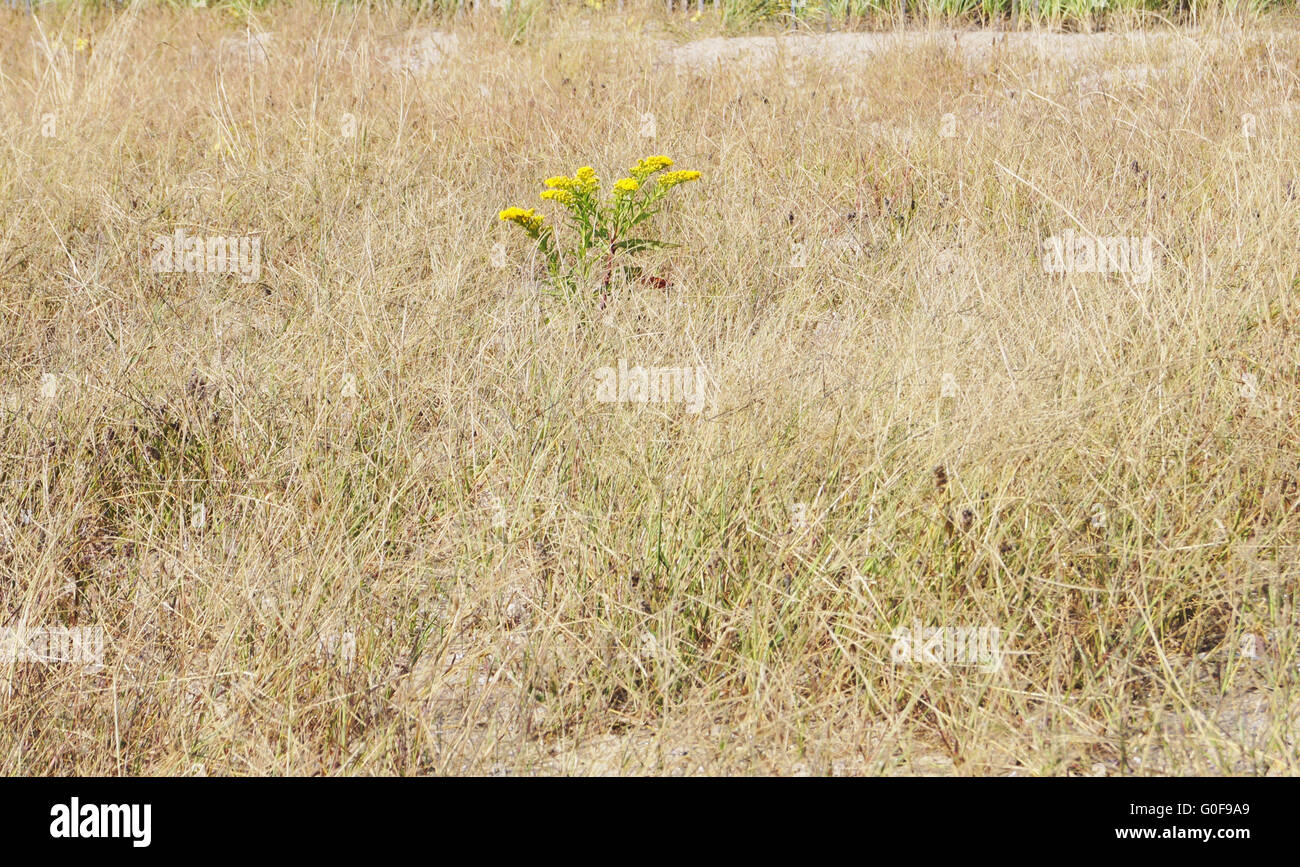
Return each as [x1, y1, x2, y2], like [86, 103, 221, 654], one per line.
[498, 156, 699, 295]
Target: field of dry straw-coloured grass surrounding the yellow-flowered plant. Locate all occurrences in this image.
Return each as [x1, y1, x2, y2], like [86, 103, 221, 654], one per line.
[0, 0, 1300, 776]
